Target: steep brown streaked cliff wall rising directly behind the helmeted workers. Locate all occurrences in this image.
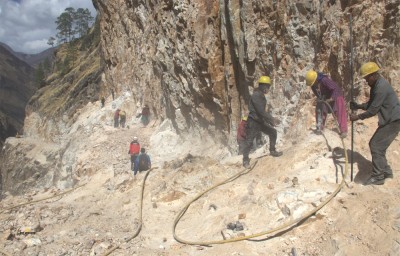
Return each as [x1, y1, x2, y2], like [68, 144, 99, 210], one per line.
[93, 0, 400, 149]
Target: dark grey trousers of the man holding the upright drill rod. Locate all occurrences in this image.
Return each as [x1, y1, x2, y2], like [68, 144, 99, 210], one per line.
[369, 120, 400, 179]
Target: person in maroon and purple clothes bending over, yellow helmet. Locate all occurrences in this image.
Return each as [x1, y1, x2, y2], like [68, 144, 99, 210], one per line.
[306, 70, 347, 138]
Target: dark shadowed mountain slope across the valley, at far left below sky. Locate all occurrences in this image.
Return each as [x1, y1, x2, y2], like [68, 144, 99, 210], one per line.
[0, 43, 39, 146]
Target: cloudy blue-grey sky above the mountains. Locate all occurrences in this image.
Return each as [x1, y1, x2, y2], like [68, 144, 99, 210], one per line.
[0, 0, 96, 54]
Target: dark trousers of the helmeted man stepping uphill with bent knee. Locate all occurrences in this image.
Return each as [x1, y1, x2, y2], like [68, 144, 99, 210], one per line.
[243, 118, 278, 163]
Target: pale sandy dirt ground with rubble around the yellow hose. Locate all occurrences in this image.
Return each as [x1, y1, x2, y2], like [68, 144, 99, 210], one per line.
[0, 117, 400, 255]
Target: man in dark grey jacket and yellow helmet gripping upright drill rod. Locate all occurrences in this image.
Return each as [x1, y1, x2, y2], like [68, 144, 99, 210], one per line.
[350, 62, 400, 185]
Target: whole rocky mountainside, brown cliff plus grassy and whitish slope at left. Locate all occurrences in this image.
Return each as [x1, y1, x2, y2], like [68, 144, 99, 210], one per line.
[0, 0, 400, 193]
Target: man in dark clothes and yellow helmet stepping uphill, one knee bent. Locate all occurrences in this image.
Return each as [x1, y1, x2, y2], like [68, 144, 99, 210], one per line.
[243, 76, 282, 168]
